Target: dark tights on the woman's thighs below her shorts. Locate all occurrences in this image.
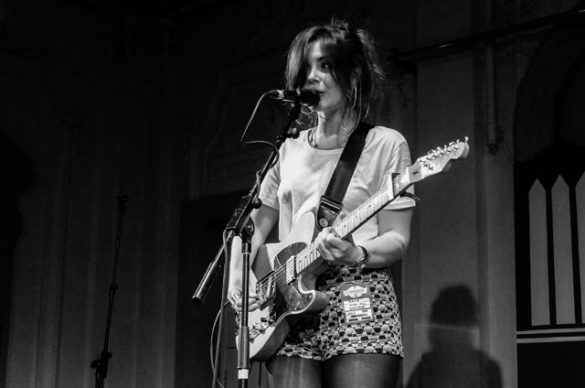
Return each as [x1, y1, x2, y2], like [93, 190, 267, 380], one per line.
[266, 354, 400, 388]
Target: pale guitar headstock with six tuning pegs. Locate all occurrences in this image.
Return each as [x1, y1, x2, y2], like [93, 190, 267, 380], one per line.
[407, 137, 469, 184]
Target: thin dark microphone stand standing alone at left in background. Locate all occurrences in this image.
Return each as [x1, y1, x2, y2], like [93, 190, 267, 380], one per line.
[90, 195, 128, 388]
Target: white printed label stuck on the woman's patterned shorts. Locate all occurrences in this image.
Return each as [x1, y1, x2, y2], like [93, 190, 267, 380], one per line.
[340, 283, 374, 324]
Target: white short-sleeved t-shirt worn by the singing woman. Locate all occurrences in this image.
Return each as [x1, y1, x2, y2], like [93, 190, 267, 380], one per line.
[259, 126, 415, 243]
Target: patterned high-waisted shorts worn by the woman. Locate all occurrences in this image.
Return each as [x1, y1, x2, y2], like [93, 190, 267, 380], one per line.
[276, 266, 403, 361]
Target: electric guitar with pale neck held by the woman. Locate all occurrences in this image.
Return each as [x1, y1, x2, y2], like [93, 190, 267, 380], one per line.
[236, 137, 469, 361]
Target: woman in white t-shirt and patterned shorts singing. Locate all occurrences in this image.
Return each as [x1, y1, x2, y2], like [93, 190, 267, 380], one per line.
[229, 21, 414, 388]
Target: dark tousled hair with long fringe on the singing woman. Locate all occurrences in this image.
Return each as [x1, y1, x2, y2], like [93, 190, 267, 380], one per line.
[285, 19, 386, 122]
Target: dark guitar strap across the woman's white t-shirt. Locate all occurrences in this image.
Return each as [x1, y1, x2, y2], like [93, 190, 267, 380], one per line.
[317, 122, 372, 230]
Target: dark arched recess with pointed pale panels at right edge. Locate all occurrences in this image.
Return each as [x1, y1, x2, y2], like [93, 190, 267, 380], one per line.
[514, 4, 585, 387]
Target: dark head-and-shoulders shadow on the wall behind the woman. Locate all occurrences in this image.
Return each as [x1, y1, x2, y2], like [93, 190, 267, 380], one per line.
[407, 285, 502, 388]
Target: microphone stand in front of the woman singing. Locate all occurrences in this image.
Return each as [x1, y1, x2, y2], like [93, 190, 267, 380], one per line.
[191, 101, 301, 388]
